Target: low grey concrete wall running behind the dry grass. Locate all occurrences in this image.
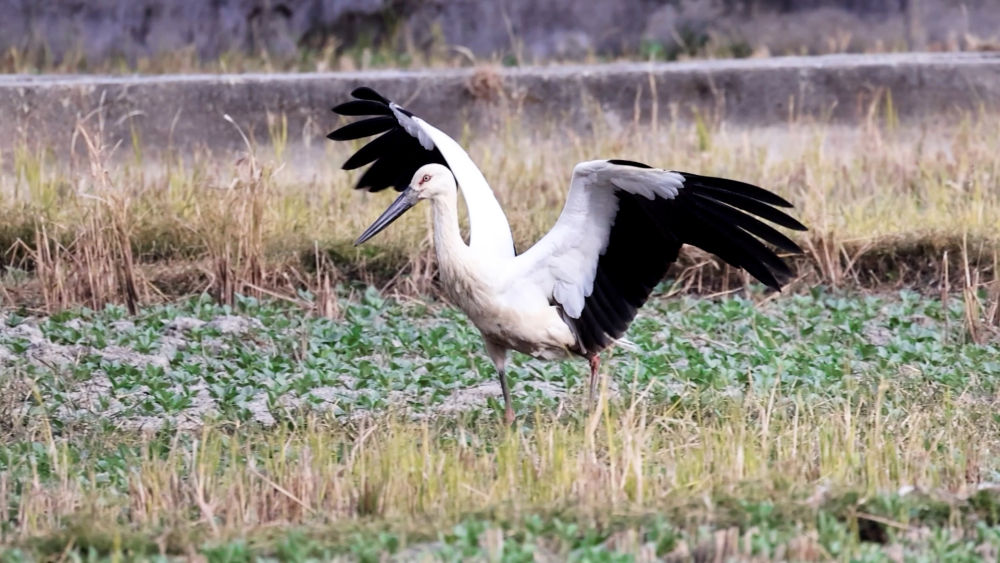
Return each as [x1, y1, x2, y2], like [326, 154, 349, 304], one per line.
[0, 54, 1000, 152]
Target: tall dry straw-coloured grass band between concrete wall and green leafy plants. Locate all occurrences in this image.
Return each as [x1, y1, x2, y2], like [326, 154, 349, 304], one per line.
[0, 104, 1000, 323]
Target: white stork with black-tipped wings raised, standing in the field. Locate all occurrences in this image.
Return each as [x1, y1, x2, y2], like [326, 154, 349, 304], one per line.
[327, 87, 806, 424]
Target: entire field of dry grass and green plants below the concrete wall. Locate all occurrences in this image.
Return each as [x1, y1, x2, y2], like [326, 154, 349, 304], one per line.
[0, 89, 1000, 561]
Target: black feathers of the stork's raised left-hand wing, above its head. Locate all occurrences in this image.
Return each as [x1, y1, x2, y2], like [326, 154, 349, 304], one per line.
[327, 86, 448, 192]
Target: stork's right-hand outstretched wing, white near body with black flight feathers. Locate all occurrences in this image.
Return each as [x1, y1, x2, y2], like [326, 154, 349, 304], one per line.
[516, 160, 806, 355]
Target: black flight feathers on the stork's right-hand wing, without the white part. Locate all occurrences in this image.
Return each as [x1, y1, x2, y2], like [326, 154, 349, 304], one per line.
[566, 164, 805, 356]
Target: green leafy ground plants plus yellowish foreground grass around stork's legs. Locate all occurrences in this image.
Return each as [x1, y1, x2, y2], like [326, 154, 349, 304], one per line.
[0, 286, 1000, 561]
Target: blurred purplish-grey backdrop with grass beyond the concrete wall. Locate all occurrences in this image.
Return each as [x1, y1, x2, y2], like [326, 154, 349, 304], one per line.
[0, 0, 1000, 73]
